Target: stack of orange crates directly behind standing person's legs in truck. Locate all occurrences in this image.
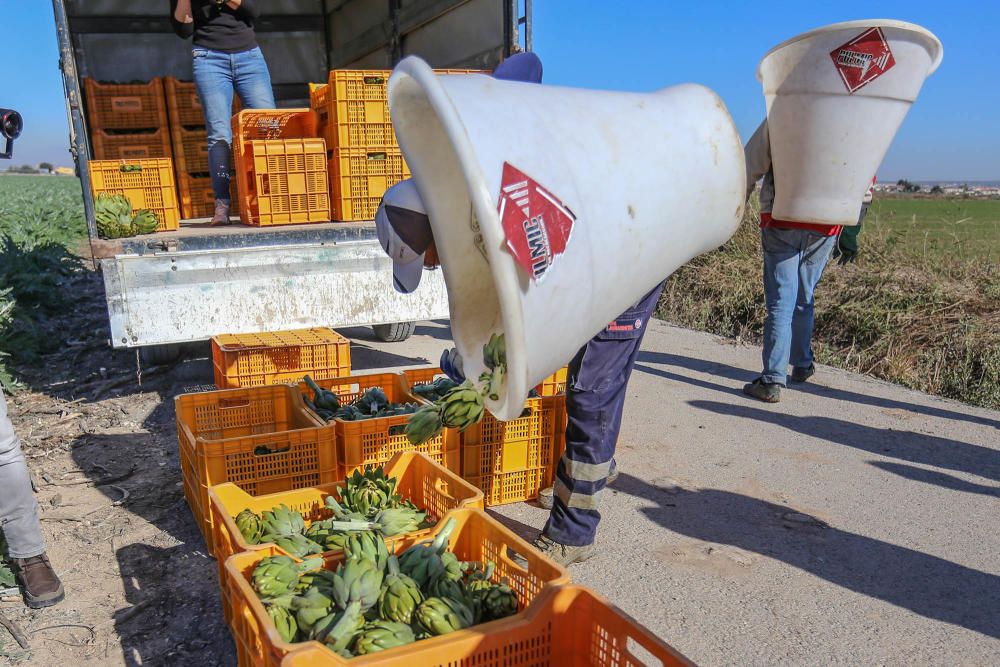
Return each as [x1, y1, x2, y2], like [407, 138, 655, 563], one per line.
[163, 76, 241, 218]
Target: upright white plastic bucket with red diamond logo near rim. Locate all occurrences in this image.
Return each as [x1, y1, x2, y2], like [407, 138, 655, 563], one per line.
[757, 19, 943, 225]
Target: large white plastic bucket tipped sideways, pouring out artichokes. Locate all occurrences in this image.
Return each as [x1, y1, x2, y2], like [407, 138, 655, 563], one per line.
[389, 57, 746, 420]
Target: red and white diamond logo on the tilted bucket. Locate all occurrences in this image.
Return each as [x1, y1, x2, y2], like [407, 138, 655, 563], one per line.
[497, 162, 576, 282]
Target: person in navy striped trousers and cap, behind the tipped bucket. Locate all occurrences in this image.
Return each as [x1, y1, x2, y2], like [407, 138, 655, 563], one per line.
[375, 53, 663, 566]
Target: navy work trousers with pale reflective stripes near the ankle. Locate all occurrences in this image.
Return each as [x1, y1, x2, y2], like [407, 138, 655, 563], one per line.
[545, 283, 663, 546]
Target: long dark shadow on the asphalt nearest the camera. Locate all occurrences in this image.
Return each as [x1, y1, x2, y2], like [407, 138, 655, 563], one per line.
[615, 473, 1000, 638]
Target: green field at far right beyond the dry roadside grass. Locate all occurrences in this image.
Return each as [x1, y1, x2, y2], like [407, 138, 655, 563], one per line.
[865, 198, 1000, 262]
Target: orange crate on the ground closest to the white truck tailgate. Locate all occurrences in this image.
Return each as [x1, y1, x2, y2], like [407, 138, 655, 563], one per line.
[212, 327, 351, 389]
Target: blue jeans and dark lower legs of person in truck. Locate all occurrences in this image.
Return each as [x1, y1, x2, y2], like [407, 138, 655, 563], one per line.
[191, 47, 274, 201]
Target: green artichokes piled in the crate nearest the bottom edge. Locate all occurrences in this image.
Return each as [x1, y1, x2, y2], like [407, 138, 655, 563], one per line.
[251, 519, 520, 657]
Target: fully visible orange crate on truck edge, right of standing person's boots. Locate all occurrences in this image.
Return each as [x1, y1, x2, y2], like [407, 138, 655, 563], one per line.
[243, 139, 330, 226]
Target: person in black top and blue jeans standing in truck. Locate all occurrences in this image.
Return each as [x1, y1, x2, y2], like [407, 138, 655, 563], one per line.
[170, 0, 274, 225]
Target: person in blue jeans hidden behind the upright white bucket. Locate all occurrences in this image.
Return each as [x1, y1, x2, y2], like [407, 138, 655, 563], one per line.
[743, 120, 875, 403]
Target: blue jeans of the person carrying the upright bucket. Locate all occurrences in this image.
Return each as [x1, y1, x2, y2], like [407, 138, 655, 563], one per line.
[760, 227, 837, 386]
